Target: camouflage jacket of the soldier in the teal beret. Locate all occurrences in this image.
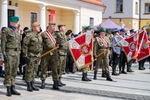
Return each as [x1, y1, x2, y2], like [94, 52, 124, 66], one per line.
[1, 28, 21, 56]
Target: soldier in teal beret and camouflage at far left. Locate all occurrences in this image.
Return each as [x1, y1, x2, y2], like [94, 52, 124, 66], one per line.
[1, 16, 21, 96]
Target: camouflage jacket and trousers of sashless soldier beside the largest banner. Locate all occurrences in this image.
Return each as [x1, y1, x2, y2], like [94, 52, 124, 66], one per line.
[56, 32, 68, 78]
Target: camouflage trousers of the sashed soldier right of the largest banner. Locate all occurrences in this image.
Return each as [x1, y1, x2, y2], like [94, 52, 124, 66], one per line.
[95, 52, 109, 73]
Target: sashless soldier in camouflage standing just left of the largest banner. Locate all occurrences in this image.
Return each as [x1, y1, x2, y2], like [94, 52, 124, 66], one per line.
[56, 24, 68, 86]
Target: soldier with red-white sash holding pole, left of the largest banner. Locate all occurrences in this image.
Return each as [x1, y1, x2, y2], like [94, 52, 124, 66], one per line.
[41, 22, 59, 90]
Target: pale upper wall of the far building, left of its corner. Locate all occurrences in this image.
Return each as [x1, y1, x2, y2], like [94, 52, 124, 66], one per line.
[101, 0, 135, 18]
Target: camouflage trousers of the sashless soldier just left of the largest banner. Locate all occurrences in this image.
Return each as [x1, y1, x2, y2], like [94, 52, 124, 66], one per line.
[58, 56, 66, 78]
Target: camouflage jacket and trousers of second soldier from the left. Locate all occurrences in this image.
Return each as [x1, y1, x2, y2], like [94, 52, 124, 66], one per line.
[23, 32, 42, 82]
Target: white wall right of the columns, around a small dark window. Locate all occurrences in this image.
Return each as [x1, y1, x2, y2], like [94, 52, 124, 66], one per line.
[80, 7, 102, 30]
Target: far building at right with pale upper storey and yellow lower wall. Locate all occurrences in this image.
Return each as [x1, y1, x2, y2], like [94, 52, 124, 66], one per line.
[101, 0, 150, 29]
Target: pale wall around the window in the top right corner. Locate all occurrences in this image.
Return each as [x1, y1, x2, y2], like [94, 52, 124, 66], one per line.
[141, 0, 150, 19]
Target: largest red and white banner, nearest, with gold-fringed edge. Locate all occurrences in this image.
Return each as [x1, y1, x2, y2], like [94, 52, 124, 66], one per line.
[69, 31, 93, 69]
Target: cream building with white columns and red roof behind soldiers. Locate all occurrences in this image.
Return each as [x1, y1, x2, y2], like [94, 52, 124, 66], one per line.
[0, 0, 105, 33]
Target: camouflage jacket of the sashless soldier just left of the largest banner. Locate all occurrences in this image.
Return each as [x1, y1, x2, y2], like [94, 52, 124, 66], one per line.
[56, 32, 68, 56]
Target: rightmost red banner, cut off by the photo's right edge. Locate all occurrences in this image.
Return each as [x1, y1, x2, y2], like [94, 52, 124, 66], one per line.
[137, 30, 150, 61]
